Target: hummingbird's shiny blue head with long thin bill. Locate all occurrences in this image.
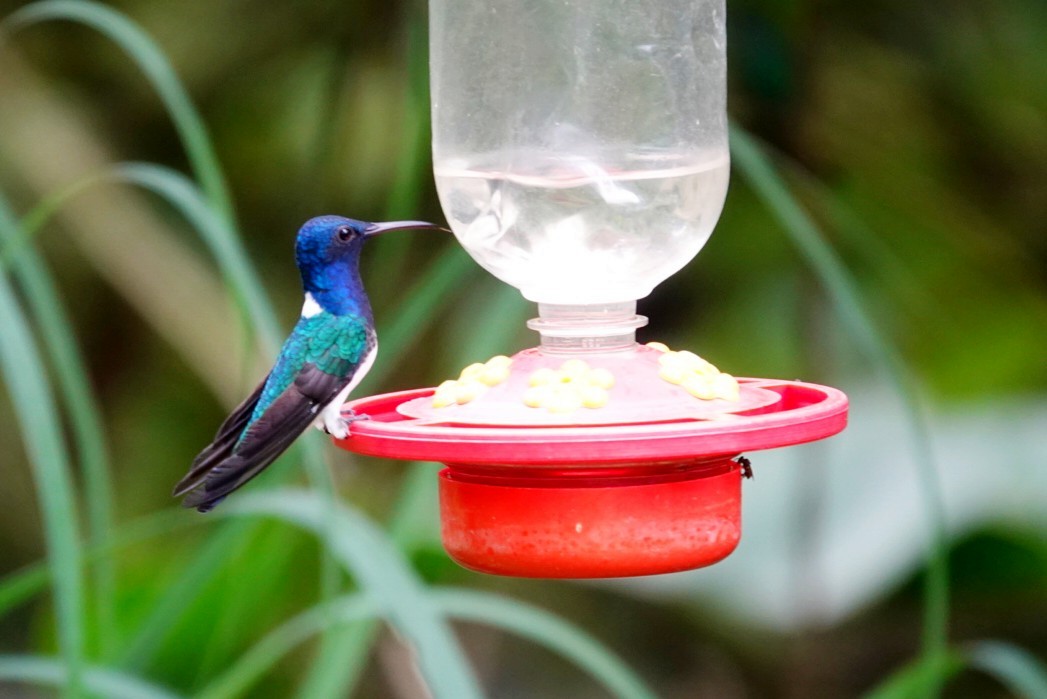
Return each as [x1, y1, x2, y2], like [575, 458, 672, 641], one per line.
[294, 216, 439, 316]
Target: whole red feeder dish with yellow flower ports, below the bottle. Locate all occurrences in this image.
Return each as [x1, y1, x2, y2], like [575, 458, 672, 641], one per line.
[336, 343, 847, 578]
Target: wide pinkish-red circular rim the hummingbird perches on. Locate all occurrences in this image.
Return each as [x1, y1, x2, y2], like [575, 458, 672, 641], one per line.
[336, 379, 847, 466]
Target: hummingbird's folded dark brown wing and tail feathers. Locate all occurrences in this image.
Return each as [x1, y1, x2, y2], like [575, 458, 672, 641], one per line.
[173, 363, 352, 512]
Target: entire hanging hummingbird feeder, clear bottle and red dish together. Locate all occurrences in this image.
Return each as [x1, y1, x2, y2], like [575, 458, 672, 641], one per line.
[337, 0, 847, 578]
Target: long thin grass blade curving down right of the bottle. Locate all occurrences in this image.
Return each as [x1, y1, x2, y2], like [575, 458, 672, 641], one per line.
[731, 126, 949, 696]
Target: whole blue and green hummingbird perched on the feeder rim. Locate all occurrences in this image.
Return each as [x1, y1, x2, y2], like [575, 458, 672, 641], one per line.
[174, 216, 446, 512]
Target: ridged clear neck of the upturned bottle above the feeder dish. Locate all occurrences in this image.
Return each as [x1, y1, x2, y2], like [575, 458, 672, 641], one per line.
[527, 301, 647, 354]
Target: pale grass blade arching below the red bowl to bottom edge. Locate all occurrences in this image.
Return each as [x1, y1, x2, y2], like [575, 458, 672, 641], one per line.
[429, 588, 655, 699]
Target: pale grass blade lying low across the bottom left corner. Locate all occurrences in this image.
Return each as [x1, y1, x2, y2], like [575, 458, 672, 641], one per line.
[0, 655, 178, 699]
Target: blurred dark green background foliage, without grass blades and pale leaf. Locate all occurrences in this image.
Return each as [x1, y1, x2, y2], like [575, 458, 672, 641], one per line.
[0, 0, 1047, 699]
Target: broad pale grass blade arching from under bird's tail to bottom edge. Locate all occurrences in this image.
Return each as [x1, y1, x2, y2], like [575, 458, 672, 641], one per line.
[224, 491, 482, 699]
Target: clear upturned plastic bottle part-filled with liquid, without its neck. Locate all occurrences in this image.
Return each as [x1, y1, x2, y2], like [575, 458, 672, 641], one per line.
[429, 0, 729, 341]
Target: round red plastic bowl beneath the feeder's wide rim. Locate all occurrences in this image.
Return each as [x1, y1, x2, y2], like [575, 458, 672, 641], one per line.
[440, 460, 741, 578]
